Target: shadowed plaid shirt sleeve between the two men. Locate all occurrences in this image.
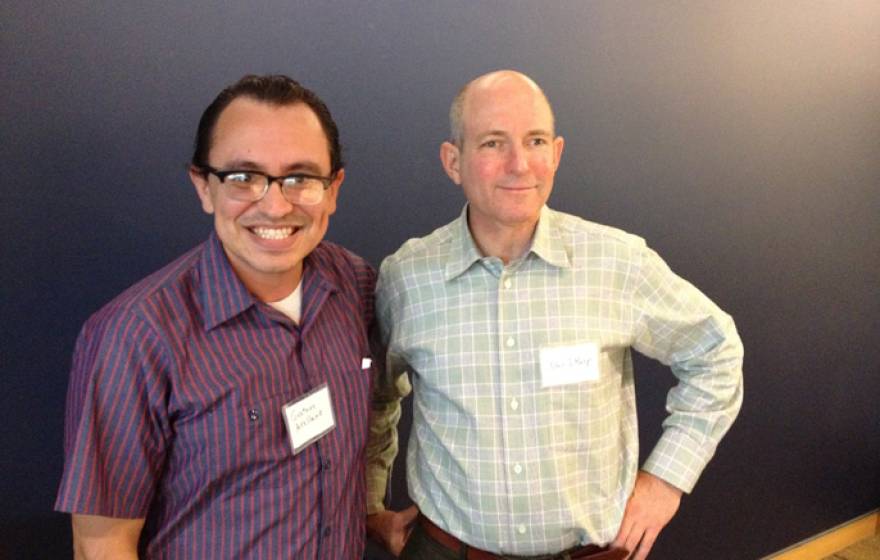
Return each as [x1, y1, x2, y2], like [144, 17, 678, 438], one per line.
[366, 261, 411, 515]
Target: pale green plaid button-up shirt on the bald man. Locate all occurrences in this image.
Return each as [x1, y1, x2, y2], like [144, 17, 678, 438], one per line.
[368, 207, 742, 555]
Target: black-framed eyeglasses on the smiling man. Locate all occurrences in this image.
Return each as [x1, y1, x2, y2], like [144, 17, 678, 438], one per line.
[199, 165, 333, 206]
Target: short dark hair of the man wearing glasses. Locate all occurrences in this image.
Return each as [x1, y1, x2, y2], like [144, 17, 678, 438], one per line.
[192, 74, 344, 175]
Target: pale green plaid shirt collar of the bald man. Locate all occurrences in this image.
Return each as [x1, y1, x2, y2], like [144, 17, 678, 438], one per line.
[446, 204, 571, 281]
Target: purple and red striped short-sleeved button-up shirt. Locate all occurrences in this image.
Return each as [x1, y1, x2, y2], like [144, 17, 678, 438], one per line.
[55, 231, 375, 560]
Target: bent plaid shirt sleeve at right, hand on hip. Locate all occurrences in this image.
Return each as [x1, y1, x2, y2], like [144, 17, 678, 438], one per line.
[633, 248, 743, 492]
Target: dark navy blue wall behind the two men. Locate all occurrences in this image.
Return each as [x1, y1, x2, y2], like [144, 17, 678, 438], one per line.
[0, 0, 880, 560]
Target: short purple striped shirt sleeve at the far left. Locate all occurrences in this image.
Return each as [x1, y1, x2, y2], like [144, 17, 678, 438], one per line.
[55, 310, 170, 519]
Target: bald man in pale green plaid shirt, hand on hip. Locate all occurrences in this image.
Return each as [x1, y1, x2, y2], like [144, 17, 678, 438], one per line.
[367, 71, 743, 560]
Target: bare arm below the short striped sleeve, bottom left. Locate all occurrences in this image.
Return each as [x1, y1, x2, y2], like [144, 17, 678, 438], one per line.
[71, 513, 144, 560]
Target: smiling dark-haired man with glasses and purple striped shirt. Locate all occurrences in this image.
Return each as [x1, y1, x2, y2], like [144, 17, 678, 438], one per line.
[56, 76, 375, 560]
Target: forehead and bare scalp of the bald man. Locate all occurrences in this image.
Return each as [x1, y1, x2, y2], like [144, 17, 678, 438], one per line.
[462, 78, 553, 135]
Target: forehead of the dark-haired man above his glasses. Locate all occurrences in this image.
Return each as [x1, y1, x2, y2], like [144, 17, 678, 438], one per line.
[209, 97, 330, 170]
